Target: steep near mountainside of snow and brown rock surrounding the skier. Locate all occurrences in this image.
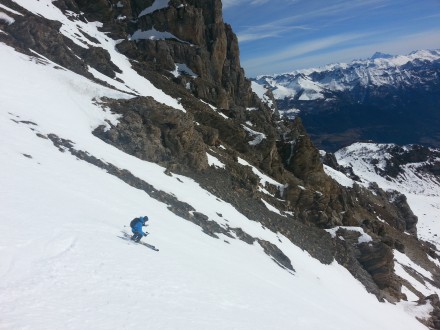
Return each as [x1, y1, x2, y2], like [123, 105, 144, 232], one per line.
[0, 0, 440, 329]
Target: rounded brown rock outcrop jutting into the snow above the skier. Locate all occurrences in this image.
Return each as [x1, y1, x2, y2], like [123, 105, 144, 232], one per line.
[94, 97, 208, 170]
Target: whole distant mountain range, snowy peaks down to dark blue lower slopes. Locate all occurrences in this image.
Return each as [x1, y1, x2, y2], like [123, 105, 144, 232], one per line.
[255, 50, 440, 151]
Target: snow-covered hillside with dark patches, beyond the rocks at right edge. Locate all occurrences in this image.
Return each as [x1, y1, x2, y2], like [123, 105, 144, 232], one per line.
[335, 143, 440, 246]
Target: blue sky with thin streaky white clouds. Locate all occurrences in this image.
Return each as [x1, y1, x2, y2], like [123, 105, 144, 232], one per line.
[223, 0, 440, 77]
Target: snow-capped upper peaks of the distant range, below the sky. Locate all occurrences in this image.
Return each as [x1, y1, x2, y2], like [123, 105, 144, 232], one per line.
[256, 50, 440, 101]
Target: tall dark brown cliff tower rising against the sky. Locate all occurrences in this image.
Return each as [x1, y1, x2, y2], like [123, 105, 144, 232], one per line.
[77, 0, 258, 109]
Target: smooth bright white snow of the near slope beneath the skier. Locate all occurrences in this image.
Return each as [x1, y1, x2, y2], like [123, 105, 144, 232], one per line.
[0, 0, 434, 330]
